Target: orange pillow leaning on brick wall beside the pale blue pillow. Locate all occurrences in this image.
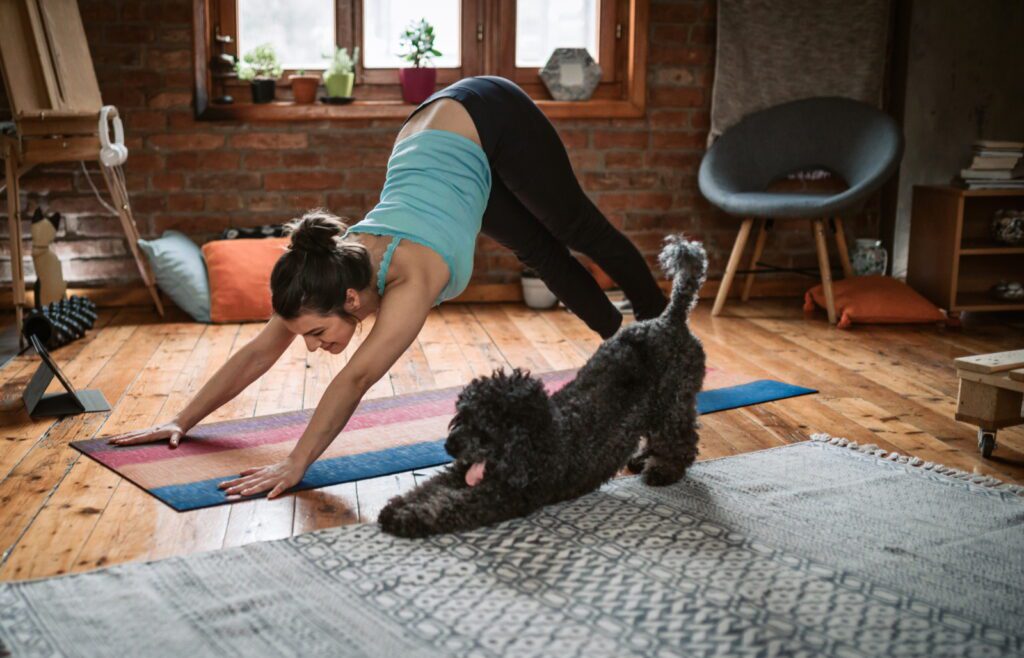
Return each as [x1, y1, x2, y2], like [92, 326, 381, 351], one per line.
[203, 237, 290, 322]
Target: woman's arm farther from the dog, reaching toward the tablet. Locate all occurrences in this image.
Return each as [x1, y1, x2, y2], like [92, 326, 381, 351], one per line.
[109, 315, 295, 448]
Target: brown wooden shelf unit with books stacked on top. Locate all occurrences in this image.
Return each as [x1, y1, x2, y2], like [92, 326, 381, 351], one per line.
[906, 185, 1024, 314]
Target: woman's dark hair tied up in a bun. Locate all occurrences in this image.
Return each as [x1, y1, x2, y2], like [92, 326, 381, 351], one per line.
[270, 208, 373, 323]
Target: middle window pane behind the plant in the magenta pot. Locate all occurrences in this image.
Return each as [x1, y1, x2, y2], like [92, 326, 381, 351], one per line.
[362, 0, 462, 69]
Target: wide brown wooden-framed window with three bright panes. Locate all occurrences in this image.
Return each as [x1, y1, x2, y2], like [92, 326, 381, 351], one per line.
[193, 0, 649, 120]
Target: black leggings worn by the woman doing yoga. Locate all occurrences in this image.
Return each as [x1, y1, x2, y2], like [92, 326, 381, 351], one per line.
[407, 76, 667, 338]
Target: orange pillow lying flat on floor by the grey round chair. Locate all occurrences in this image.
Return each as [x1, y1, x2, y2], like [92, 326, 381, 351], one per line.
[804, 275, 946, 328]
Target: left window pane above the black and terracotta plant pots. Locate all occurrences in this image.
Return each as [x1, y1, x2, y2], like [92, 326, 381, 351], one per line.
[238, 0, 335, 69]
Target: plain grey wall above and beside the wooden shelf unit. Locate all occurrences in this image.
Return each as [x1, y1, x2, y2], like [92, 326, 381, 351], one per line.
[892, 0, 1024, 276]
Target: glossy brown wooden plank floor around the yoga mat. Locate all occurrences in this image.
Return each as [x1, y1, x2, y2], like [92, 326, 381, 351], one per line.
[0, 301, 1024, 580]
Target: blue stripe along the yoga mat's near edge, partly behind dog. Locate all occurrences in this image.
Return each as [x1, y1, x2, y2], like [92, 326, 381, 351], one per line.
[150, 380, 817, 512]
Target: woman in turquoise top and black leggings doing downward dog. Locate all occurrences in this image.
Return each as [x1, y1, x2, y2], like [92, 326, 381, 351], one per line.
[111, 77, 666, 498]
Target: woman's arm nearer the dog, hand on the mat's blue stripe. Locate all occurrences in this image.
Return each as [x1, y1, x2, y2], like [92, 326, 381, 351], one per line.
[220, 280, 433, 498]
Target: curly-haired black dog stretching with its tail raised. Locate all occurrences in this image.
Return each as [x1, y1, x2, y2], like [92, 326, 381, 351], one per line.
[379, 236, 707, 537]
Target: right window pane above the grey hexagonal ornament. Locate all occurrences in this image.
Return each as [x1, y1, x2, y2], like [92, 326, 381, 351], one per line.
[515, 0, 599, 68]
